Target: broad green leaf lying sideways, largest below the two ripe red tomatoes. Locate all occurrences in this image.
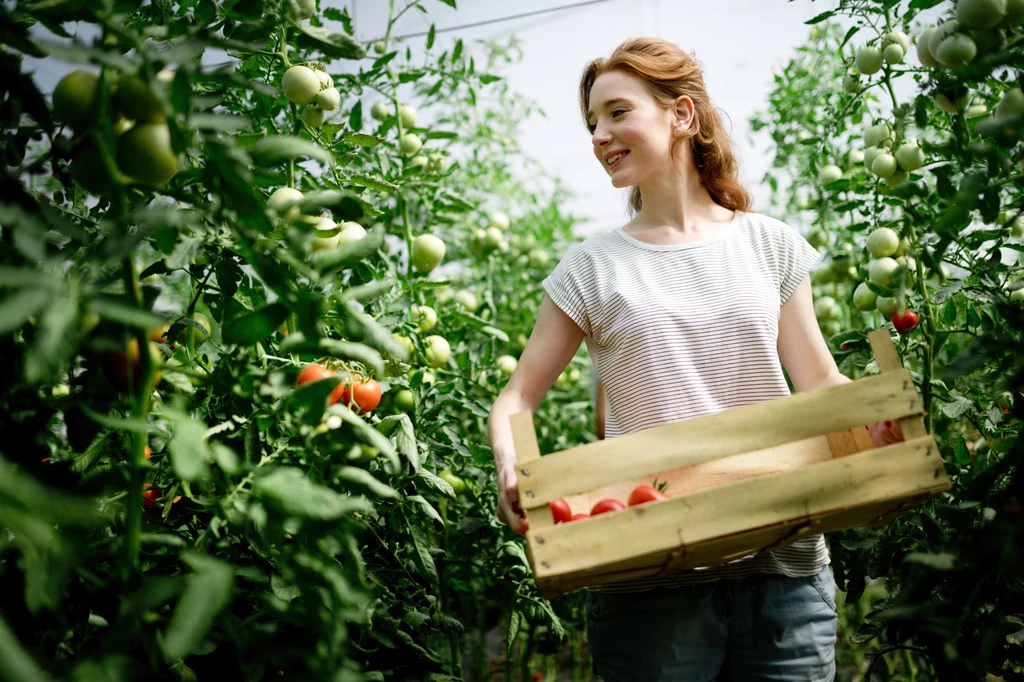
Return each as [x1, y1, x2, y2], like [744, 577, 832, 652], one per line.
[253, 464, 374, 521]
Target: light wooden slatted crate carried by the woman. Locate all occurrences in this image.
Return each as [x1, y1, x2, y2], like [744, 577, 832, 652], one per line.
[512, 330, 950, 598]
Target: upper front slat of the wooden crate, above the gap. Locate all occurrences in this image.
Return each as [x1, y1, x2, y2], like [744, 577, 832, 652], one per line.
[517, 370, 922, 509]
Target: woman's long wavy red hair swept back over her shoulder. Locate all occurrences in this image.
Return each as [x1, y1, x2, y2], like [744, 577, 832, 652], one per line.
[580, 38, 751, 215]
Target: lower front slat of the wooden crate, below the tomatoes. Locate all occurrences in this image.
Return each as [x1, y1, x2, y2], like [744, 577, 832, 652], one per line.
[531, 436, 949, 579]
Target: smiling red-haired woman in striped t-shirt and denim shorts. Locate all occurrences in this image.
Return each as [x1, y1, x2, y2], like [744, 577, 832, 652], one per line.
[488, 38, 902, 682]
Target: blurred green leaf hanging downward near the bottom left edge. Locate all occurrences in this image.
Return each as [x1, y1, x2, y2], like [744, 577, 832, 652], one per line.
[161, 552, 234, 660]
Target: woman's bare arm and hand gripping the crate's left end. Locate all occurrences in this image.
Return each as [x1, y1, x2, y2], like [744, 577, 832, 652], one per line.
[487, 297, 584, 532]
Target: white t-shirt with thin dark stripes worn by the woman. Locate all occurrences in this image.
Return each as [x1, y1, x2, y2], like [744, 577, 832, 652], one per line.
[544, 212, 829, 592]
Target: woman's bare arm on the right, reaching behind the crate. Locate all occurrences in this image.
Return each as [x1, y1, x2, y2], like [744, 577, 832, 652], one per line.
[778, 276, 903, 446]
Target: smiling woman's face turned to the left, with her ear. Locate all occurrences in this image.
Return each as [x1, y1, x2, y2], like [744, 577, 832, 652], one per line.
[588, 71, 688, 187]
